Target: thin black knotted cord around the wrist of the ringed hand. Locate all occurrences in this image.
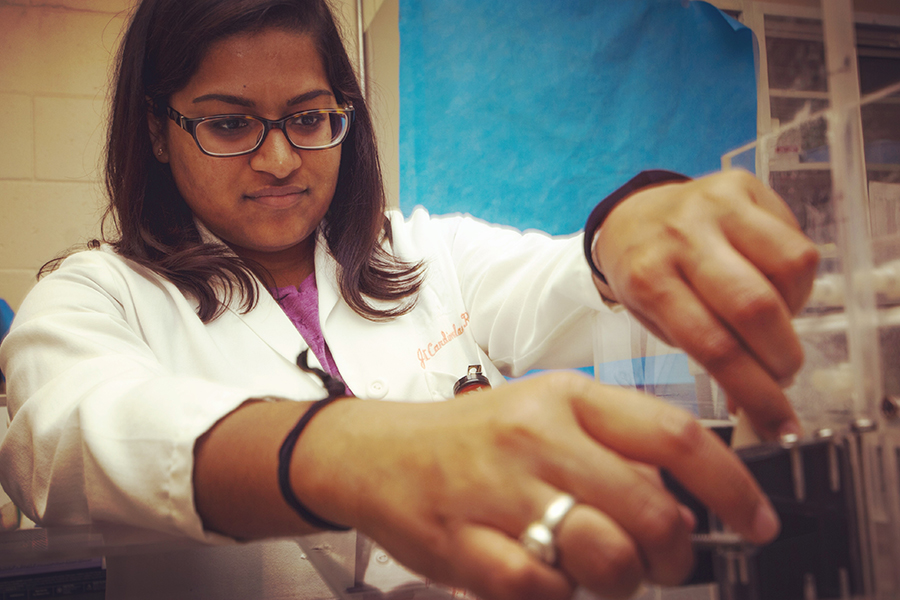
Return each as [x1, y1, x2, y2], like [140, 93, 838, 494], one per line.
[278, 349, 350, 531]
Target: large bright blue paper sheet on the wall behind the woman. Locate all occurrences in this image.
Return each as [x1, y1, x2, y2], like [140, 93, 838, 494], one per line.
[400, 0, 756, 234]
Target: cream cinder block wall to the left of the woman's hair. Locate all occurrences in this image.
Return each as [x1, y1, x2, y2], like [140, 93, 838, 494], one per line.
[0, 0, 131, 310]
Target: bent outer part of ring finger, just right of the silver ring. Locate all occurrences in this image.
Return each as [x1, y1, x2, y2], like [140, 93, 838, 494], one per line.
[556, 504, 645, 598]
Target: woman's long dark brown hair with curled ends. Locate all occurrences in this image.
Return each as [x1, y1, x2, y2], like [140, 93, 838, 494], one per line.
[93, 0, 424, 321]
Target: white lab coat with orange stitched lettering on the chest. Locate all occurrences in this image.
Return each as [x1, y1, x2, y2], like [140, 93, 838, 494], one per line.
[0, 210, 630, 541]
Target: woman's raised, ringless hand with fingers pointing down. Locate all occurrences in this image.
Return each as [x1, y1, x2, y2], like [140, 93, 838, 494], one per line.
[593, 171, 819, 438]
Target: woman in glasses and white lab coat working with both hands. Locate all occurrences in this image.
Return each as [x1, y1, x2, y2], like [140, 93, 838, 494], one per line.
[0, 0, 816, 598]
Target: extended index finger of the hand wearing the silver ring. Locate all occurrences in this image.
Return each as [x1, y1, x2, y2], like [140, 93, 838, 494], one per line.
[574, 388, 779, 543]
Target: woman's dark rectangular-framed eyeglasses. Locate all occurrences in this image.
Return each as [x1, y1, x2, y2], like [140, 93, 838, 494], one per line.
[166, 104, 353, 156]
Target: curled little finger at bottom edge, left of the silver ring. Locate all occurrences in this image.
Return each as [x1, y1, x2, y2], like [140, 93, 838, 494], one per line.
[451, 525, 573, 600]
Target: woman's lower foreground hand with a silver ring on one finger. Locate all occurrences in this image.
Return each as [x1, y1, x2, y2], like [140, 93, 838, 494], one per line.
[292, 373, 778, 600]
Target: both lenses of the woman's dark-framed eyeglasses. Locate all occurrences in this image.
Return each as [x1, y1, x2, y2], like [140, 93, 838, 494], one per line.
[196, 112, 349, 154]
